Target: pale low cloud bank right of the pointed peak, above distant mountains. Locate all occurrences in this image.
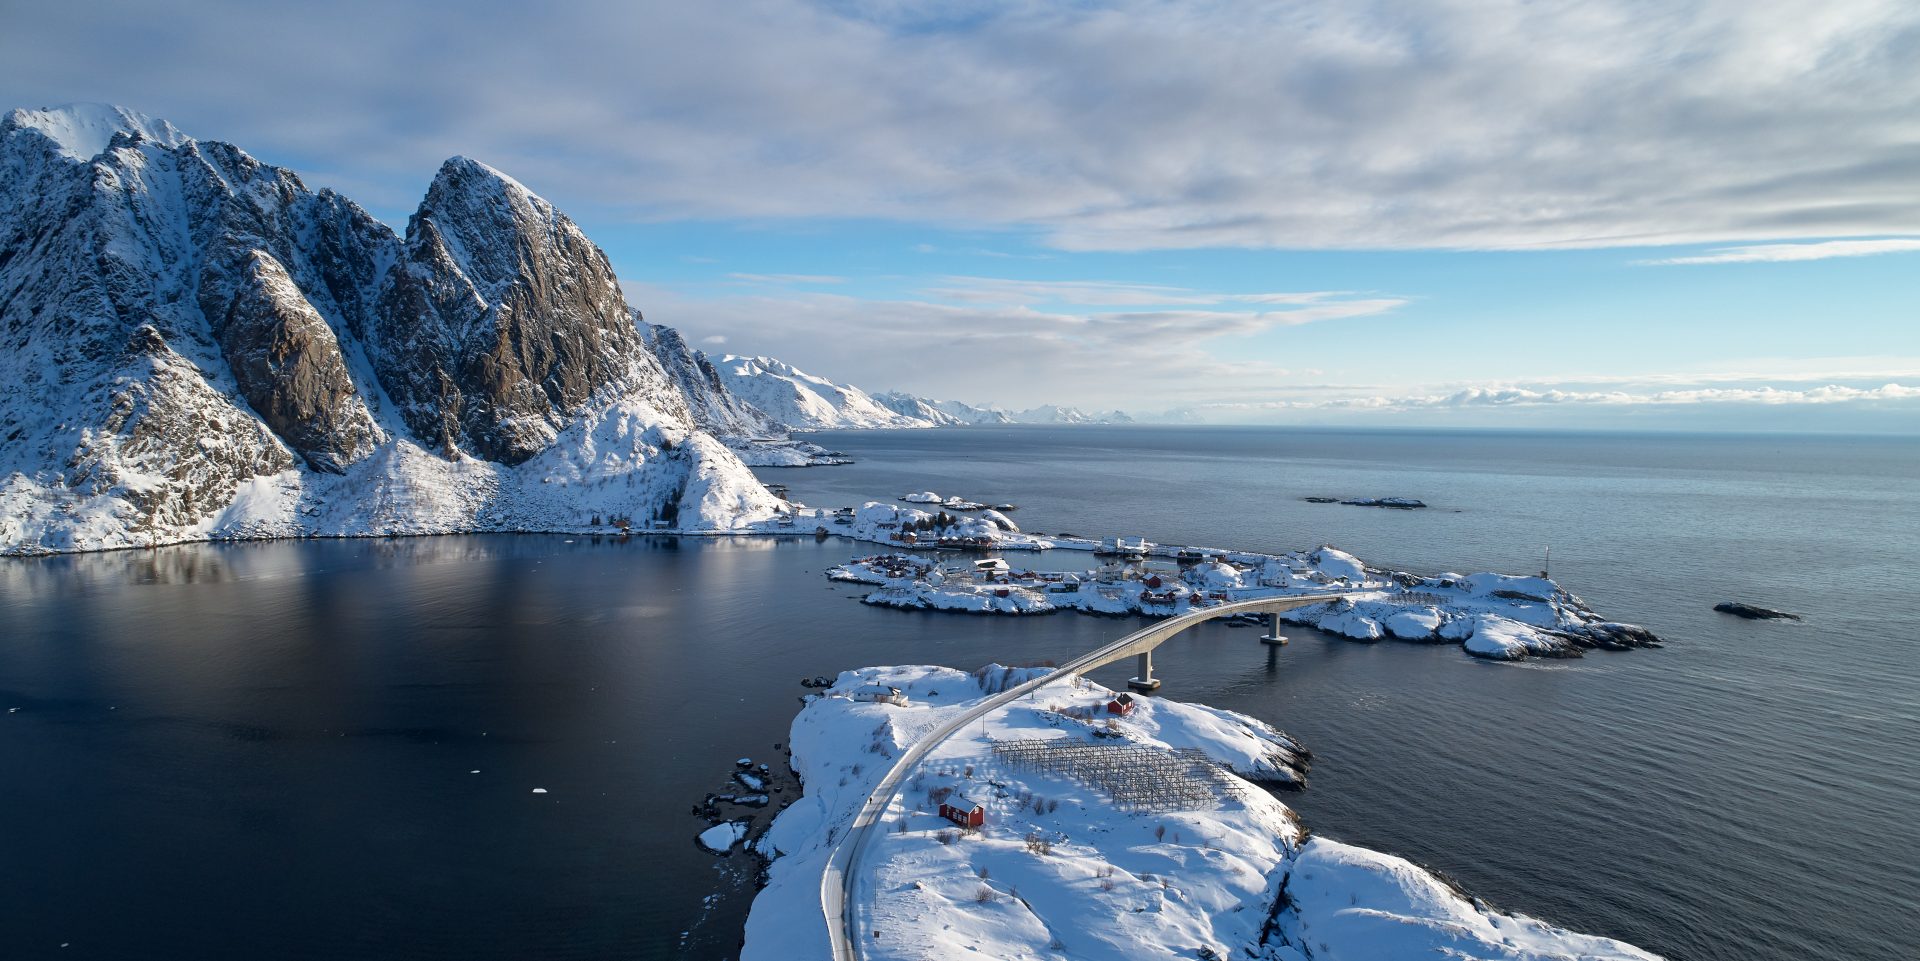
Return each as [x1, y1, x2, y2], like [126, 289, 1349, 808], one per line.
[628, 278, 1405, 409]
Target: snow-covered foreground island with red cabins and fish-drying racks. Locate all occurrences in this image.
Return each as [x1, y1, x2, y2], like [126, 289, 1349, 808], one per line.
[737, 666, 1655, 961]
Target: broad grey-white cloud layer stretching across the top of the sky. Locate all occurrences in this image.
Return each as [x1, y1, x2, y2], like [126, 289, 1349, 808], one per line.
[15, 0, 1920, 249]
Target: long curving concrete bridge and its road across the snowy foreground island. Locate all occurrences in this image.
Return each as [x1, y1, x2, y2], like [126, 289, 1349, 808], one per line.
[820, 593, 1346, 961]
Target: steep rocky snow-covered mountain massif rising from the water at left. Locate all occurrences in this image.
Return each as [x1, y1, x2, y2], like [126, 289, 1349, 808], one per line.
[0, 105, 780, 552]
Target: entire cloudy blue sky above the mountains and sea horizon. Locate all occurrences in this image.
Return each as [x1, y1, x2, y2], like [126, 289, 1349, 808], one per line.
[0, 0, 1920, 434]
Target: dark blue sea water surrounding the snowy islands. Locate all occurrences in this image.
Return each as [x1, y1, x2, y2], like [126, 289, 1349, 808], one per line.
[0, 428, 1920, 961]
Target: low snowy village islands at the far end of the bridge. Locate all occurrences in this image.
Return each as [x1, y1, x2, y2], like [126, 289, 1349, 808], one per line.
[816, 503, 1659, 660]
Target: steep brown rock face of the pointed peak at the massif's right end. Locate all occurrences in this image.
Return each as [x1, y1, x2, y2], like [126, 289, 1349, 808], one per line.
[378, 157, 685, 464]
